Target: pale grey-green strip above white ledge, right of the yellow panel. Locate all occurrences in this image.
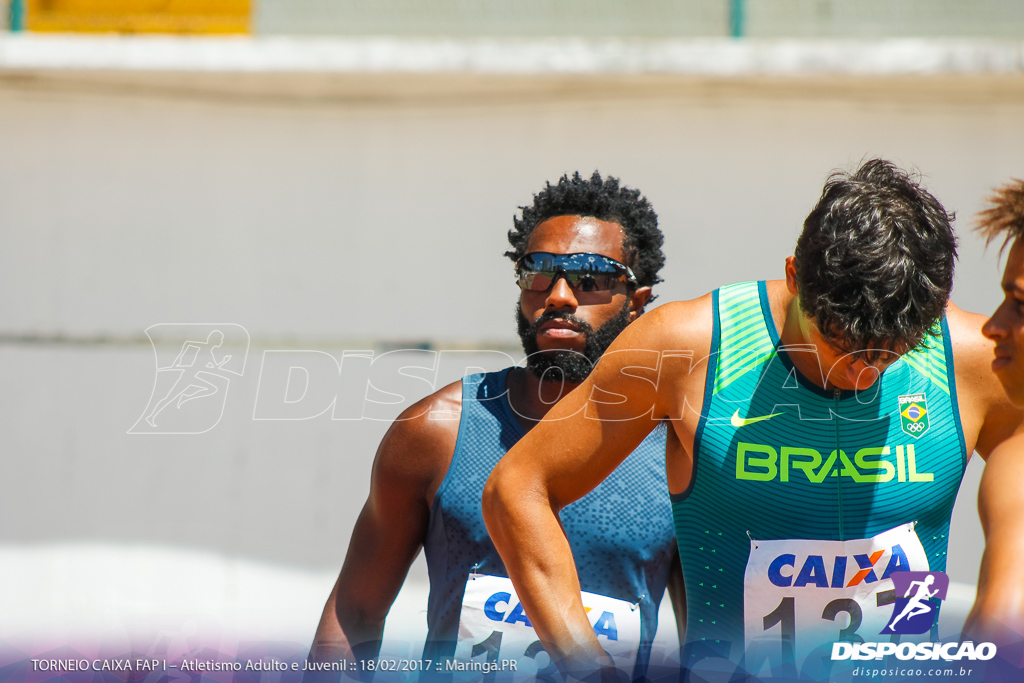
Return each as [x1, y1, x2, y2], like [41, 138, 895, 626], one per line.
[254, 0, 1024, 38]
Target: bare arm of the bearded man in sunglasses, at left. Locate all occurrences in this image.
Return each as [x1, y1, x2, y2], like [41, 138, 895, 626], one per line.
[309, 382, 461, 661]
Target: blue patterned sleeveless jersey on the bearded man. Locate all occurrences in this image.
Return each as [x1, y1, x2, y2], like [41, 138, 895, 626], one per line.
[424, 369, 676, 678]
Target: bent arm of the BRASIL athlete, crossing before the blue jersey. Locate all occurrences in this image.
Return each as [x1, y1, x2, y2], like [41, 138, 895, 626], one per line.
[483, 297, 711, 675]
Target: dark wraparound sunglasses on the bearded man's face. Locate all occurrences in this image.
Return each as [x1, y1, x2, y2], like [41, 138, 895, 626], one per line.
[515, 252, 637, 298]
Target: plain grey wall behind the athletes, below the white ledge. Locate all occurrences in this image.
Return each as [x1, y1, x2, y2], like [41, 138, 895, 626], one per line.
[0, 70, 1024, 583]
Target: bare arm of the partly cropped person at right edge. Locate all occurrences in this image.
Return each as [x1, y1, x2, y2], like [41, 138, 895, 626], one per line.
[964, 434, 1024, 645]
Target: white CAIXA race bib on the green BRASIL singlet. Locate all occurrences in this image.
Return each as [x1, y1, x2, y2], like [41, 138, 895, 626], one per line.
[743, 523, 929, 675]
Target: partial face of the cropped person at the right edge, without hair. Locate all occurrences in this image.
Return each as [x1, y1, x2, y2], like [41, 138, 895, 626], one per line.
[981, 240, 1024, 407]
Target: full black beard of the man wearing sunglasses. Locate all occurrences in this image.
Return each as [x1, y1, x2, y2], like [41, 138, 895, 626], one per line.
[515, 299, 630, 384]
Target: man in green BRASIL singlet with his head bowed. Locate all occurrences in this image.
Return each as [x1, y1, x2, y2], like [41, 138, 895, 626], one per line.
[483, 160, 1024, 677]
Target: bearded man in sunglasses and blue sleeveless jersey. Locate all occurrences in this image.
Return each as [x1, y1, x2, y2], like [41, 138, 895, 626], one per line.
[311, 173, 682, 679]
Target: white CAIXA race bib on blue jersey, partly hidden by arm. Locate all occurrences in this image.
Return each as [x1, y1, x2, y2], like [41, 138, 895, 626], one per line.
[449, 574, 640, 681]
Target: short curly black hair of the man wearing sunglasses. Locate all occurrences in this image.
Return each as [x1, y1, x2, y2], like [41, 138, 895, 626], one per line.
[505, 171, 665, 290]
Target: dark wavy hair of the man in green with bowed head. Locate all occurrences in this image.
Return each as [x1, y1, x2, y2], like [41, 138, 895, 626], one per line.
[796, 159, 956, 361]
